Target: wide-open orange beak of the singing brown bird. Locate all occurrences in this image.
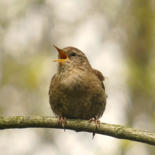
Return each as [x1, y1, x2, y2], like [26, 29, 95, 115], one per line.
[53, 45, 68, 62]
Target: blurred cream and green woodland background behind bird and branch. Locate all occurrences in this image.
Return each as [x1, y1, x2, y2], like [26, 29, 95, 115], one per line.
[0, 0, 155, 155]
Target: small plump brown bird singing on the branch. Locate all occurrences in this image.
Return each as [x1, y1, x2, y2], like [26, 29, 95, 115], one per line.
[49, 46, 106, 124]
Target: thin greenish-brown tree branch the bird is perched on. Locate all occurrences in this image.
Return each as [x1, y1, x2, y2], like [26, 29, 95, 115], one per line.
[0, 116, 155, 145]
